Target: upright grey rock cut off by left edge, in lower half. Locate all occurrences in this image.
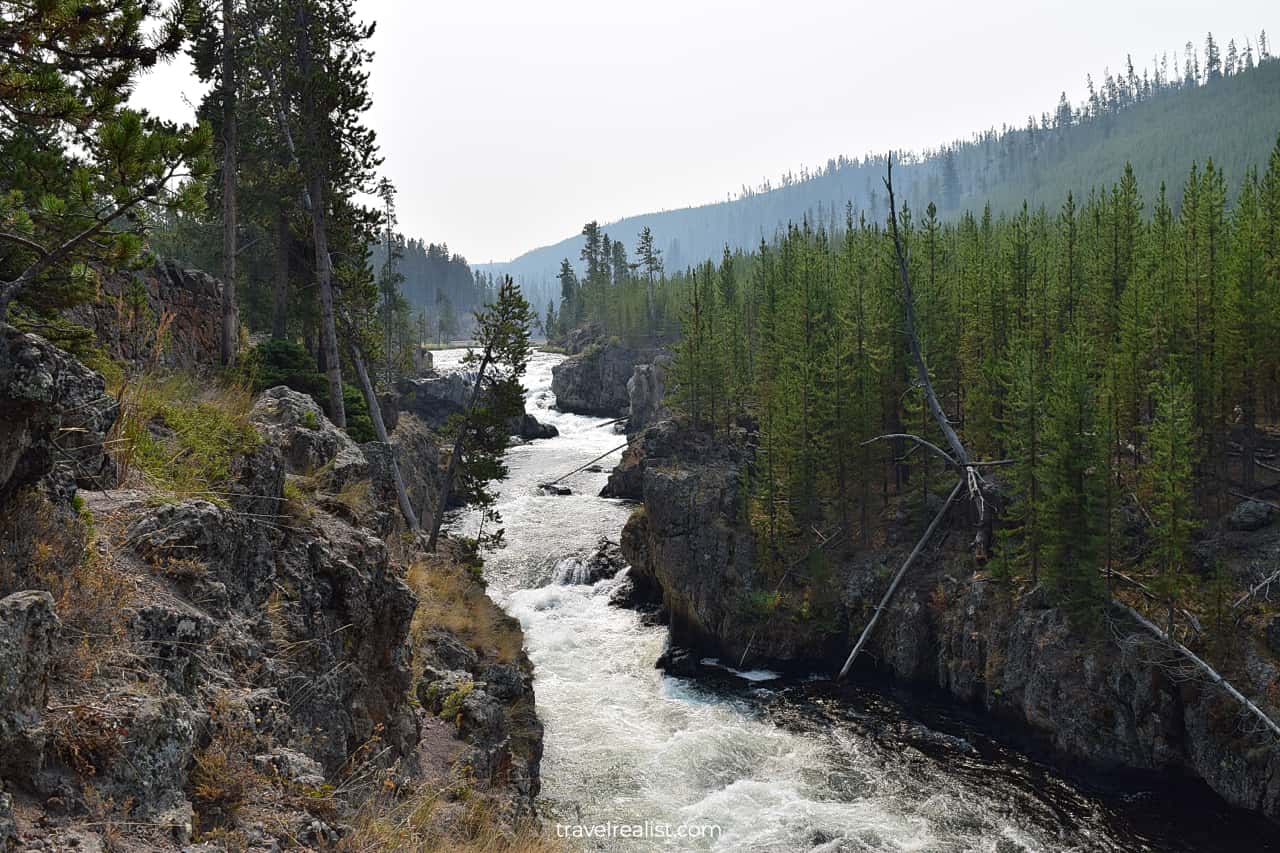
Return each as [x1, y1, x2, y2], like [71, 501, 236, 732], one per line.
[0, 590, 60, 777]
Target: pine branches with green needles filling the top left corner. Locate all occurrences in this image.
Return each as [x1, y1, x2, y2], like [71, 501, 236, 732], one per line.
[0, 0, 210, 324]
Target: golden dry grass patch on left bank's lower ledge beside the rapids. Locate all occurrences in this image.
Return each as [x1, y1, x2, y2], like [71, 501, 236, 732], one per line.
[406, 555, 524, 663]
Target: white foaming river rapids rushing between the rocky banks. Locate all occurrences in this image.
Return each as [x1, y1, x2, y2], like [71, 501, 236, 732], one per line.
[436, 351, 1280, 853]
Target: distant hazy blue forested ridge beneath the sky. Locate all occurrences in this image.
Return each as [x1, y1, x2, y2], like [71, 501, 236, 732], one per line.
[486, 35, 1280, 304]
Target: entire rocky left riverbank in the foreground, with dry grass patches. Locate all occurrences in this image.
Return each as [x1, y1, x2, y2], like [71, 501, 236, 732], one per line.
[0, 320, 541, 850]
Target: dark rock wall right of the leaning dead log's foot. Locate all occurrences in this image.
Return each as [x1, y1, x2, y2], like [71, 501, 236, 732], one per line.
[859, 578, 1280, 820]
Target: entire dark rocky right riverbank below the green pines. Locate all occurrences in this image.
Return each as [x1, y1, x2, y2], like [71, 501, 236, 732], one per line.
[605, 421, 1280, 821]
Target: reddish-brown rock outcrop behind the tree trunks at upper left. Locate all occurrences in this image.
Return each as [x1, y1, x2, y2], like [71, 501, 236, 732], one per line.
[68, 260, 223, 369]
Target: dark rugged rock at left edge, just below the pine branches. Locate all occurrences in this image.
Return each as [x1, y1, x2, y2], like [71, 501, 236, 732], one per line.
[0, 323, 119, 503]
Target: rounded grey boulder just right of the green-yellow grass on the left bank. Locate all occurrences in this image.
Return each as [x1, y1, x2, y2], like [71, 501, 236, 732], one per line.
[250, 386, 369, 492]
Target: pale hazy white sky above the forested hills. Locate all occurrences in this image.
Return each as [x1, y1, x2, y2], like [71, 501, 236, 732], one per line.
[136, 0, 1280, 263]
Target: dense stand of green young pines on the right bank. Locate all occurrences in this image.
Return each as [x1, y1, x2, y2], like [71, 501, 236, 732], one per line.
[559, 138, 1280, 621]
